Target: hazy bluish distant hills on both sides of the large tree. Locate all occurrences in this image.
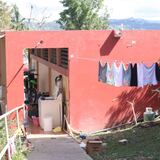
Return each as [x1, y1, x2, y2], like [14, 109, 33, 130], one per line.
[28, 18, 160, 30]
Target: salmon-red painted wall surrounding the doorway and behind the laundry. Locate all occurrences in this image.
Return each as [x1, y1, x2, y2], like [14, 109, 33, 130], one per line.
[6, 31, 160, 131]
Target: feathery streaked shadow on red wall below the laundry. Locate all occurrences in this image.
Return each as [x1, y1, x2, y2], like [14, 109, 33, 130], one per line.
[105, 85, 160, 128]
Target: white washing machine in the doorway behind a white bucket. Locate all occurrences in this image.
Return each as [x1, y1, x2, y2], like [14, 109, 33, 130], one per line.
[38, 95, 62, 129]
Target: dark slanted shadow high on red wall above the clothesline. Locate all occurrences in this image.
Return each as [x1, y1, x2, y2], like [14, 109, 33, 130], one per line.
[100, 30, 120, 56]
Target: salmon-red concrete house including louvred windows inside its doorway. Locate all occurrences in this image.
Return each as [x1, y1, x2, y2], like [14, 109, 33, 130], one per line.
[0, 30, 160, 131]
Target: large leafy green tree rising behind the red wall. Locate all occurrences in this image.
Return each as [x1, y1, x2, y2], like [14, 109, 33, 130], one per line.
[57, 0, 109, 30]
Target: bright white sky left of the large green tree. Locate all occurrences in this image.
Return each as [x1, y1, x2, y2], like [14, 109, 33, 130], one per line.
[6, 0, 63, 21]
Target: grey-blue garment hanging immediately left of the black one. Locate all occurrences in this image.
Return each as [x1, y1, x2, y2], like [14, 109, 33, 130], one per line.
[123, 64, 131, 86]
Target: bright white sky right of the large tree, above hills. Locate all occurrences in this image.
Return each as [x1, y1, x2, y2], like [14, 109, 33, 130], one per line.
[104, 0, 160, 19]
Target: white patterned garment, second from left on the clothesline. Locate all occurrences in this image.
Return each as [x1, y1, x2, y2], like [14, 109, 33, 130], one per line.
[106, 63, 114, 85]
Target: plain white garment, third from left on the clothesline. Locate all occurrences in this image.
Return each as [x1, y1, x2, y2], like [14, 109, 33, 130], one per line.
[113, 63, 124, 87]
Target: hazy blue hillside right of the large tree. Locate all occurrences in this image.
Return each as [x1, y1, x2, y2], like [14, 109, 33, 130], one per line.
[109, 18, 160, 30]
